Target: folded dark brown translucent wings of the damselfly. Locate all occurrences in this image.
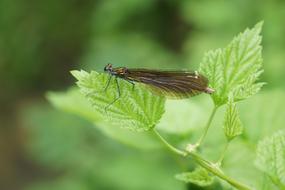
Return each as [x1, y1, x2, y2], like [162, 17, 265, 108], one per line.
[125, 69, 213, 99]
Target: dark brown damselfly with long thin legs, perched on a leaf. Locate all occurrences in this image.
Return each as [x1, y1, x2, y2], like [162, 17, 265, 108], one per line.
[98, 64, 214, 111]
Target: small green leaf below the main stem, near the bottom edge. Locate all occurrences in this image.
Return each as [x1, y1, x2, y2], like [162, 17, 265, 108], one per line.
[175, 167, 214, 186]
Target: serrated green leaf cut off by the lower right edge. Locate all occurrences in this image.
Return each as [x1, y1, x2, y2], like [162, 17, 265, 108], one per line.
[255, 130, 285, 189]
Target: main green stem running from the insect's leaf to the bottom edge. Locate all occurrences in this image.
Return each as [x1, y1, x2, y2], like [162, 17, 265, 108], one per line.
[153, 129, 252, 190]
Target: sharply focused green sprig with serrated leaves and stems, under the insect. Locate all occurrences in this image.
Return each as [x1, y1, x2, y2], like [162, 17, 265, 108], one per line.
[56, 23, 268, 189]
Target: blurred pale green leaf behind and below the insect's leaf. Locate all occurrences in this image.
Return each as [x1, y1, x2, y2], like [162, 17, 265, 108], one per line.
[47, 88, 161, 150]
